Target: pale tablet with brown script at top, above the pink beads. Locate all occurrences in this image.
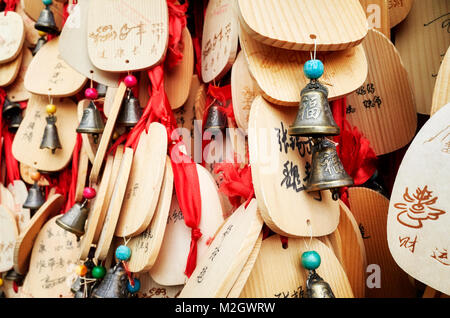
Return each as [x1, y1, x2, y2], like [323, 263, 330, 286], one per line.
[87, 0, 169, 72]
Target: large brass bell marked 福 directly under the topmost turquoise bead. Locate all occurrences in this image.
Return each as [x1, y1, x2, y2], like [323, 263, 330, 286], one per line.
[289, 80, 340, 136]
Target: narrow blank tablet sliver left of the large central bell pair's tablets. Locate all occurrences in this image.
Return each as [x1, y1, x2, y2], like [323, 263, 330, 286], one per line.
[231, 51, 261, 131]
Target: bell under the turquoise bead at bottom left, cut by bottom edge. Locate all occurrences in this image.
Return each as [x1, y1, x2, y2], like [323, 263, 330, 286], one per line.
[92, 263, 128, 298]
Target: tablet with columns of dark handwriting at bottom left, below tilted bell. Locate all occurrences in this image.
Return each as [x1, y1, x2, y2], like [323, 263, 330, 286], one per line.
[22, 217, 80, 298]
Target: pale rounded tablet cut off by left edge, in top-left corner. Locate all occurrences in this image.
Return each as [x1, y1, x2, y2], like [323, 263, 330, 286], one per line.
[0, 11, 25, 64]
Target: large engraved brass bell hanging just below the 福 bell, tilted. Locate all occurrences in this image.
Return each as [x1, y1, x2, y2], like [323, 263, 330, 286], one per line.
[306, 138, 353, 200]
